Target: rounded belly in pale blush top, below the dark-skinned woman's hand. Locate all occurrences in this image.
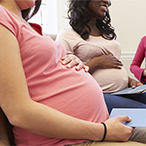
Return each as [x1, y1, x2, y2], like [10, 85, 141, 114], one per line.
[93, 67, 128, 93]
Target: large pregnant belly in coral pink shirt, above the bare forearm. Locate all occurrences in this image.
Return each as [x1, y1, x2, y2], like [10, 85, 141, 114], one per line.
[34, 68, 108, 122]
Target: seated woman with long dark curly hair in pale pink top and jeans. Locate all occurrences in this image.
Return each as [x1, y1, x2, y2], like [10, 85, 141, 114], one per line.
[56, 0, 146, 112]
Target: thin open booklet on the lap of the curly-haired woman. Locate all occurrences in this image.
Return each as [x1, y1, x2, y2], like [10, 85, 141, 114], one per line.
[112, 85, 146, 95]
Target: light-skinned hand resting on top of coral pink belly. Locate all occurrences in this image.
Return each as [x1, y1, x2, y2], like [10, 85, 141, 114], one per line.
[61, 54, 89, 72]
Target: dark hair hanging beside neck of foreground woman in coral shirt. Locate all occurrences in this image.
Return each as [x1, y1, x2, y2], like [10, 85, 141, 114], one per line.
[21, 0, 42, 21]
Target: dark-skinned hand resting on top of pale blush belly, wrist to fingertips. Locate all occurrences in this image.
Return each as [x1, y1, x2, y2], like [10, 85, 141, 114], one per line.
[94, 54, 123, 69]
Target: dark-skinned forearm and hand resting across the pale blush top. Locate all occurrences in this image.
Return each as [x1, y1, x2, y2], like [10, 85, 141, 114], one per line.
[86, 54, 123, 74]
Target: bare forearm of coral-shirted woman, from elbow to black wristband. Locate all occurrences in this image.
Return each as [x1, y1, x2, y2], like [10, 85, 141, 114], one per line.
[8, 101, 104, 141]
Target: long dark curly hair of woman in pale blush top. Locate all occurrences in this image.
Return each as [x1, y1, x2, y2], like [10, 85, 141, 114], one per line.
[67, 0, 116, 40]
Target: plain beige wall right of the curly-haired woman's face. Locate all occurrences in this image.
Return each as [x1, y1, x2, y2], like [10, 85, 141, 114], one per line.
[109, 0, 146, 52]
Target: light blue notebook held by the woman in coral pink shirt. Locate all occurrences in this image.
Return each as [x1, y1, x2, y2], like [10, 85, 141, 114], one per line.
[109, 108, 146, 127]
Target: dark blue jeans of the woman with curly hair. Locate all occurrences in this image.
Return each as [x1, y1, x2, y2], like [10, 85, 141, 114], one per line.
[104, 93, 146, 113]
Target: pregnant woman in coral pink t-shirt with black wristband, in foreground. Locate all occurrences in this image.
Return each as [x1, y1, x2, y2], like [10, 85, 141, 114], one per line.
[0, 0, 146, 146]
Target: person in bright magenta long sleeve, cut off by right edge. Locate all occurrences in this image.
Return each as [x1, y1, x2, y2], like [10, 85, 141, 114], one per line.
[130, 36, 146, 83]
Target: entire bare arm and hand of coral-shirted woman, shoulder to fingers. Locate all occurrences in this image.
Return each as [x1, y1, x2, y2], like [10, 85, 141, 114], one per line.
[0, 25, 133, 141]
